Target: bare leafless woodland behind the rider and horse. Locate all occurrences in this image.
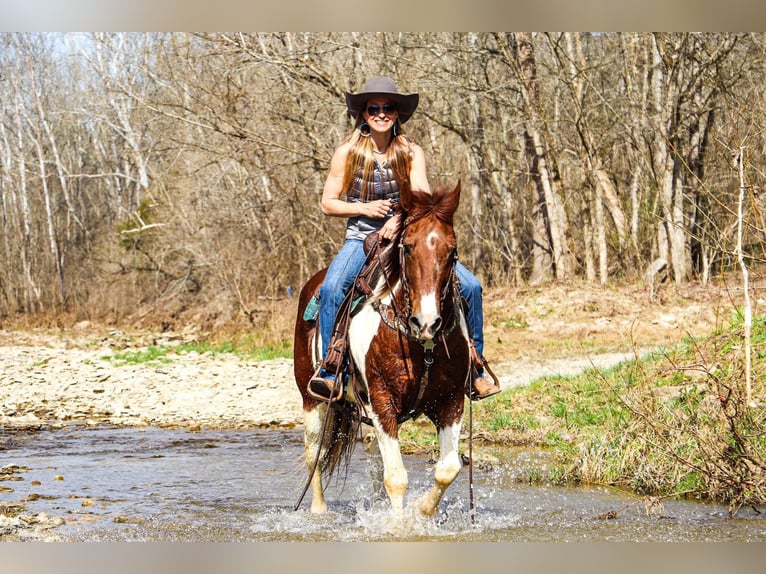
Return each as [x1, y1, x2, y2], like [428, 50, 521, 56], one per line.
[0, 33, 766, 328]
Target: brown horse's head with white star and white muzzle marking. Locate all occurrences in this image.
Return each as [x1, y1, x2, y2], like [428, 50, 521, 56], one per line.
[400, 181, 460, 341]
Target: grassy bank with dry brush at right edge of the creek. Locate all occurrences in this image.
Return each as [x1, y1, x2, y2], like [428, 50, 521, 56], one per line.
[473, 316, 766, 514]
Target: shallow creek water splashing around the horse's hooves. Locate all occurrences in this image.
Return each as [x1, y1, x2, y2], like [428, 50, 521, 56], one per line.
[0, 426, 766, 542]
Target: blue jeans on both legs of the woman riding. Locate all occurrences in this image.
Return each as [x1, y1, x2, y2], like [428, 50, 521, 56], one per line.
[319, 239, 484, 357]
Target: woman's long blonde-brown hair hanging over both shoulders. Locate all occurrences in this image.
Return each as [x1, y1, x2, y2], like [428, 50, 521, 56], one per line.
[343, 114, 412, 201]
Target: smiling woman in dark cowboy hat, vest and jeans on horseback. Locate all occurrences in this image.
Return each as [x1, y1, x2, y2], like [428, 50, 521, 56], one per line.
[309, 77, 500, 400]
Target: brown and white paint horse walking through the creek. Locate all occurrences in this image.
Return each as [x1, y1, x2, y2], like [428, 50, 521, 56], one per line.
[294, 181, 471, 516]
